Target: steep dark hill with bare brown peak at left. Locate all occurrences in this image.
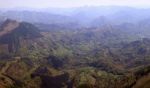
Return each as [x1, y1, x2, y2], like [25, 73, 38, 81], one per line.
[0, 20, 41, 53]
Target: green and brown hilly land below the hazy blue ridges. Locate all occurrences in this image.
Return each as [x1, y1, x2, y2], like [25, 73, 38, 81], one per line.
[0, 19, 150, 88]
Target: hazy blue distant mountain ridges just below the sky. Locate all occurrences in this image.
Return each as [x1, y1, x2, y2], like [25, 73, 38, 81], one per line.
[0, 6, 150, 26]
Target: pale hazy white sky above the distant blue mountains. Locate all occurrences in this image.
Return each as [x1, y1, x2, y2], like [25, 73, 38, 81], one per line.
[0, 0, 150, 8]
